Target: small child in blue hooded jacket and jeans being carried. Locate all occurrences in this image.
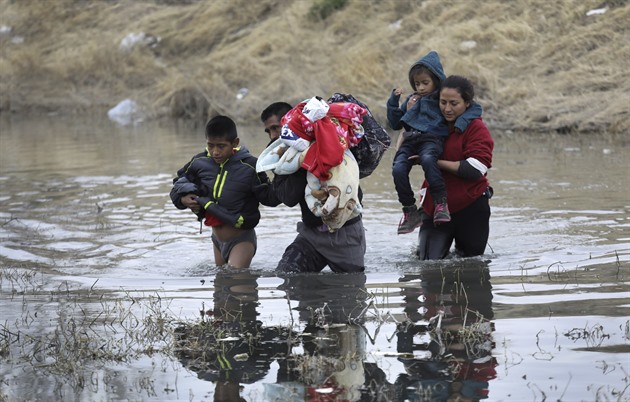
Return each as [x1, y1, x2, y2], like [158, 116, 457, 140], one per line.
[387, 50, 482, 234]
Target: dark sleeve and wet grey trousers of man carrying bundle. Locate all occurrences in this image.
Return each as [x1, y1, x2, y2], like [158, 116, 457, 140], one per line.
[271, 169, 366, 272]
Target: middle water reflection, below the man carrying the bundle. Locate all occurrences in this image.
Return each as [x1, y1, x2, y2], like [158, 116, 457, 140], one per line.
[272, 273, 368, 401]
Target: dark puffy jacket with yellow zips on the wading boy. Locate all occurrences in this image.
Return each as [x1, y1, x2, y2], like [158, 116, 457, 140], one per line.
[170, 146, 280, 229]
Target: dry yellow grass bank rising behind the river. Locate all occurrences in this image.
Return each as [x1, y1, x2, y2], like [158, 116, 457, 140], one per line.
[0, 0, 630, 133]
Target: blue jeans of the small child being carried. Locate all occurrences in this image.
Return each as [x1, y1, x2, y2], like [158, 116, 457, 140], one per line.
[392, 131, 446, 207]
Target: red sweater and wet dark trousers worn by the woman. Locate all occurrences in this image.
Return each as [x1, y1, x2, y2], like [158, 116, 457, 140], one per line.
[417, 119, 494, 260]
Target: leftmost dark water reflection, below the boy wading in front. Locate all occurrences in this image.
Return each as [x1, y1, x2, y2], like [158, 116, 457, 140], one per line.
[176, 270, 290, 402]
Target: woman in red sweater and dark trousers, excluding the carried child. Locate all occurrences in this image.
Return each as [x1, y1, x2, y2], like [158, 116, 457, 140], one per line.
[416, 75, 494, 260]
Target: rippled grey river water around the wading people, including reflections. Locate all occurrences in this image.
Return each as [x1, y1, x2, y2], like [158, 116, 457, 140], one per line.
[0, 116, 630, 401]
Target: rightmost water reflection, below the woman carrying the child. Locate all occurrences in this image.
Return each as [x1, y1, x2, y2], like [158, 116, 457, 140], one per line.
[396, 260, 497, 401]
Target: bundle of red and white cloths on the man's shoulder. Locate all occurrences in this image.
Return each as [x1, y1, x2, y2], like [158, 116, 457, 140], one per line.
[256, 96, 376, 232]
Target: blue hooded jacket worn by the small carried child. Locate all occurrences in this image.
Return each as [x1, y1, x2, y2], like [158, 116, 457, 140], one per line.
[387, 50, 482, 137]
